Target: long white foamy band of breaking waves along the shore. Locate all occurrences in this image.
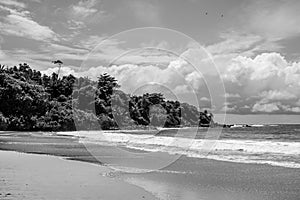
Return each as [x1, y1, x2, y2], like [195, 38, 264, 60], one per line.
[56, 131, 300, 168]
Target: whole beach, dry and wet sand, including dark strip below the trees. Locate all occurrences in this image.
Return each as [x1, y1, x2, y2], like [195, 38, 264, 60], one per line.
[0, 132, 300, 200]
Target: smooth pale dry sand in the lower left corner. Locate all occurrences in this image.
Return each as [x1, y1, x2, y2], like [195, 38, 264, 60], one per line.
[0, 151, 155, 200]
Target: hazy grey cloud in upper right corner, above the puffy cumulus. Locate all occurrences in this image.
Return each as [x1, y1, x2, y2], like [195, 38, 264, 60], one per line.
[211, 0, 300, 62]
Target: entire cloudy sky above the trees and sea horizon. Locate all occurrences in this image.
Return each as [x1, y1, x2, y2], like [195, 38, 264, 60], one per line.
[0, 0, 300, 114]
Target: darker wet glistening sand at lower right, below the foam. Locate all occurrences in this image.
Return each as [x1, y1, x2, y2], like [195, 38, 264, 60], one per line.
[124, 157, 300, 200]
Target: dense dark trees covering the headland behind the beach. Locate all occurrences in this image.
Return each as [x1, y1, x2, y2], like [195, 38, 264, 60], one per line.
[0, 64, 212, 131]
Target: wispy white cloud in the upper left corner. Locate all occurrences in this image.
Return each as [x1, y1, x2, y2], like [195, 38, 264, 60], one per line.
[0, 2, 58, 41]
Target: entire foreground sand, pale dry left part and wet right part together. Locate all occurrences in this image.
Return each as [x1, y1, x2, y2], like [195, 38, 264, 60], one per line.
[0, 150, 300, 200]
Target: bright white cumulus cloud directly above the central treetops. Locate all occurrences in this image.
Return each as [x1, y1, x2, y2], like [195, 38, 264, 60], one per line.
[69, 49, 220, 108]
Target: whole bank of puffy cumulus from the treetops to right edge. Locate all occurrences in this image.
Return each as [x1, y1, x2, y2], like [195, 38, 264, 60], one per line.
[39, 45, 300, 114]
